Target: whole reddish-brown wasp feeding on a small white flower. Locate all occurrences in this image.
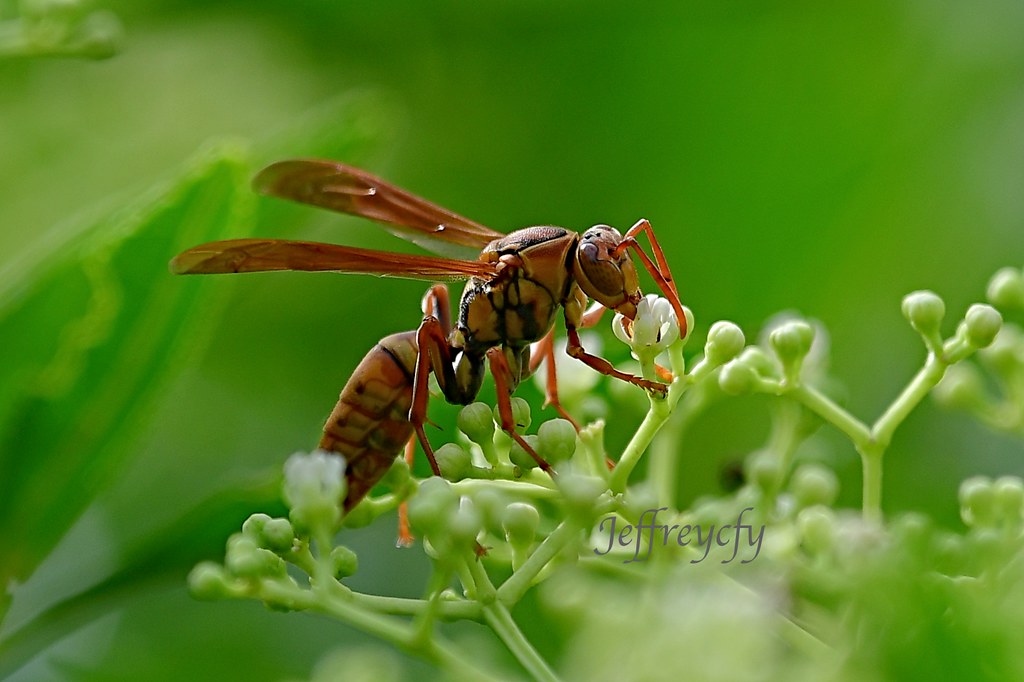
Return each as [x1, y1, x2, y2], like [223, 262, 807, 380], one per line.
[170, 159, 686, 512]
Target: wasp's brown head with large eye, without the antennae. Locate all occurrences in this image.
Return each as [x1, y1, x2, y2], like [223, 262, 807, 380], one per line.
[572, 225, 640, 319]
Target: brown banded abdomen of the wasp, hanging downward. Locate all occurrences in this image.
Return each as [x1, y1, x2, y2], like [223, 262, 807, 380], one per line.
[319, 332, 417, 512]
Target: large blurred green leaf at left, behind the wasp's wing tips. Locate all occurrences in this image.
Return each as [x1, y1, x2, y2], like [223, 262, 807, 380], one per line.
[0, 144, 253, 586]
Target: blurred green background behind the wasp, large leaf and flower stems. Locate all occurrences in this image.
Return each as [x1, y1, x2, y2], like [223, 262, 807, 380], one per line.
[0, 0, 1024, 680]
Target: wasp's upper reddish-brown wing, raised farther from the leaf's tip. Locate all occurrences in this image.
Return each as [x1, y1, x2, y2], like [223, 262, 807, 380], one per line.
[253, 159, 504, 257]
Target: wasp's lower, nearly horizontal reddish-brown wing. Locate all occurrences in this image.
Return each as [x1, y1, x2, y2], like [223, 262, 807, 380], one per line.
[170, 239, 498, 282]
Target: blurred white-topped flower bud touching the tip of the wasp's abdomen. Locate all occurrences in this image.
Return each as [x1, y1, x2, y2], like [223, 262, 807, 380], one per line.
[283, 452, 347, 530]
